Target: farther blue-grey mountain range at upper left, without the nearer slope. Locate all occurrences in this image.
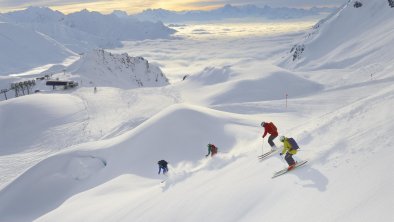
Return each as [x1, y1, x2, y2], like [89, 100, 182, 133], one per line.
[0, 7, 175, 52]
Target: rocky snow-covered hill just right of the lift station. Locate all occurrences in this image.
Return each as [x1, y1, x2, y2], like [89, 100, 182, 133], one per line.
[65, 49, 168, 89]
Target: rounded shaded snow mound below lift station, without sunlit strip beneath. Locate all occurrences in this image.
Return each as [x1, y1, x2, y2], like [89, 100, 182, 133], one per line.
[0, 94, 87, 155]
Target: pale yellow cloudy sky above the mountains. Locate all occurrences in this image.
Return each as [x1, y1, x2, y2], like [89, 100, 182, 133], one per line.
[0, 0, 347, 14]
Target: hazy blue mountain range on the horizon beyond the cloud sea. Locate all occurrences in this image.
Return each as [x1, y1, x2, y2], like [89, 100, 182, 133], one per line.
[133, 4, 336, 22]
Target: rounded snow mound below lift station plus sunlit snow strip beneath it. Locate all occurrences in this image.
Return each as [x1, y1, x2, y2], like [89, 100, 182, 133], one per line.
[0, 94, 88, 194]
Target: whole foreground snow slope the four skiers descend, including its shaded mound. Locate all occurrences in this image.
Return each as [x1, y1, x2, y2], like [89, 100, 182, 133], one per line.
[0, 77, 394, 221]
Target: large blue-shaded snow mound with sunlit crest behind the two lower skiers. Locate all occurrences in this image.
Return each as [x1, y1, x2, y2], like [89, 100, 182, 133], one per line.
[0, 103, 246, 220]
